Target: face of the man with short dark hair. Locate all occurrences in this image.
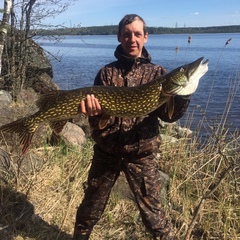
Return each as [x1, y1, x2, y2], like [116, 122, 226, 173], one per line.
[118, 19, 148, 58]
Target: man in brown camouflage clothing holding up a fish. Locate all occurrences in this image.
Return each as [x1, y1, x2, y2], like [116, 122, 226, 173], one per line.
[73, 14, 189, 240]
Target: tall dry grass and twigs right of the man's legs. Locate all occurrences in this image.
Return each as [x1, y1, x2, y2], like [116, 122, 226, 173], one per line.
[162, 124, 240, 240]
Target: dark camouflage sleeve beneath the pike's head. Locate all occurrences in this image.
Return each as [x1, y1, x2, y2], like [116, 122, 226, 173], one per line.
[153, 95, 190, 122]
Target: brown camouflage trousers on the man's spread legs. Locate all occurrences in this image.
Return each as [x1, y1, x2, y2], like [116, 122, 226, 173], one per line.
[75, 146, 170, 236]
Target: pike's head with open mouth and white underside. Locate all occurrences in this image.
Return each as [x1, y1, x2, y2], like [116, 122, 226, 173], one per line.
[162, 57, 208, 95]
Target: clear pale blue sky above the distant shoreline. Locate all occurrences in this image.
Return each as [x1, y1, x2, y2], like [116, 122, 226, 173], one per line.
[48, 0, 240, 27]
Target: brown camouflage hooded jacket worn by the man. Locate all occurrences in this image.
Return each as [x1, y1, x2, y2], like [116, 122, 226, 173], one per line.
[89, 45, 190, 155]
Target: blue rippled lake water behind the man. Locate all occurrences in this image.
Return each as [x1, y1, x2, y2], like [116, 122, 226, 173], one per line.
[37, 33, 240, 135]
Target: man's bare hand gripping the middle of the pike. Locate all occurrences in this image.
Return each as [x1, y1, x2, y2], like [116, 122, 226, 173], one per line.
[80, 94, 102, 116]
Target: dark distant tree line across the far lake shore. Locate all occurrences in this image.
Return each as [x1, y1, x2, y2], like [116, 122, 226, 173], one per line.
[33, 25, 240, 35]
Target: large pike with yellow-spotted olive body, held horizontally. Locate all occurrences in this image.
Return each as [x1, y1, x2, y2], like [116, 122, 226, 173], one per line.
[0, 58, 208, 154]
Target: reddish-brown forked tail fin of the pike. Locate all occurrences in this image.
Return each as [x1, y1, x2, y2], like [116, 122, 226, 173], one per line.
[0, 118, 37, 155]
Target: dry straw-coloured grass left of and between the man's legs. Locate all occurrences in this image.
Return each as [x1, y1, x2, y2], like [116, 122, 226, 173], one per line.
[0, 137, 152, 240]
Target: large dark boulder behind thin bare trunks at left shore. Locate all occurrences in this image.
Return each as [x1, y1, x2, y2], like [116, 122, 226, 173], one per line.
[0, 34, 59, 94]
